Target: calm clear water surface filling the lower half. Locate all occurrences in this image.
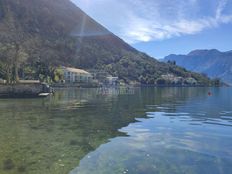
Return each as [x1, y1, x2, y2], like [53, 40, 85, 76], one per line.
[0, 88, 232, 174]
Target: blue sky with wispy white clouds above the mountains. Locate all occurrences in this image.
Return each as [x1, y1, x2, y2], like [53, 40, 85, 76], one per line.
[72, 0, 232, 58]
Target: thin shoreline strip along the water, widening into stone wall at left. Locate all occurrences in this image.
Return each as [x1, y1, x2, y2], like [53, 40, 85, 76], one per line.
[0, 83, 227, 98]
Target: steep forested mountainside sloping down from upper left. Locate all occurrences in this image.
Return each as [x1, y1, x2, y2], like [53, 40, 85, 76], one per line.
[0, 0, 214, 84]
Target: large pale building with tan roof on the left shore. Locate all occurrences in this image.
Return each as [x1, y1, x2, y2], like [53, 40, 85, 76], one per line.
[63, 67, 93, 83]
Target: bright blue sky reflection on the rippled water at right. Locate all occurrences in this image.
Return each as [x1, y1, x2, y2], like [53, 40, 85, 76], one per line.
[70, 88, 232, 174]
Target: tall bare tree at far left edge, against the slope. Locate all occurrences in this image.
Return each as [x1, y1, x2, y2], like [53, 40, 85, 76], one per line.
[0, 1, 28, 83]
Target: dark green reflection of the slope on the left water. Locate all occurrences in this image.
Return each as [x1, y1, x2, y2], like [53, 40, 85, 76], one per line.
[0, 89, 144, 174]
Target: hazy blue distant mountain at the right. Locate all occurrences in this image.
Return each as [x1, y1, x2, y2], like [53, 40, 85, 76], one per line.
[164, 49, 232, 84]
